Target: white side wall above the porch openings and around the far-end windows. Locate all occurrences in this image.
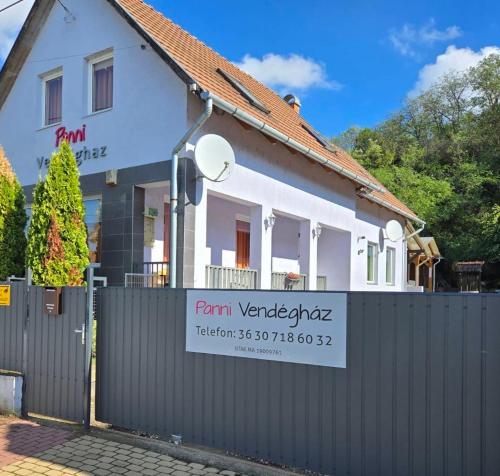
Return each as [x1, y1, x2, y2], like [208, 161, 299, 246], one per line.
[189, 101, 404, 291]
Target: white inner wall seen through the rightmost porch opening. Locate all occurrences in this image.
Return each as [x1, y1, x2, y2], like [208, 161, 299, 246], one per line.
[318, 227, 352, 291]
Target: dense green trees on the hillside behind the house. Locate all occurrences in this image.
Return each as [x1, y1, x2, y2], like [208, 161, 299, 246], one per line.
[334, 54, 500, 283]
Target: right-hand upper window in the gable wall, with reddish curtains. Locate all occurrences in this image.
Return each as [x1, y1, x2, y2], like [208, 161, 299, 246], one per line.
[89, 54, 113, 112]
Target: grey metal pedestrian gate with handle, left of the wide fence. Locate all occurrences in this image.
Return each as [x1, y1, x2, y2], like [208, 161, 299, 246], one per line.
[24, 286, 87, 423]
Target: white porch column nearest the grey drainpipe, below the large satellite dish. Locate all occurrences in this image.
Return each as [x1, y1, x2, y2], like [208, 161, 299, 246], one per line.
[193, 179, 208, 288]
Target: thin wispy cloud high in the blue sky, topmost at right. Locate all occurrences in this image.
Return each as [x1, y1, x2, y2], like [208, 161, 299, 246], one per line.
[389, 18, 462, 59]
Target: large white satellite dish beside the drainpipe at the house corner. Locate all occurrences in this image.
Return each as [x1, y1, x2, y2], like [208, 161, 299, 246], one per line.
[194, 134, 235, 182]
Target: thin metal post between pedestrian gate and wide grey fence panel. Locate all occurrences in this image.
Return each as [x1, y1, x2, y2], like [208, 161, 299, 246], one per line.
[83, 265, 94, 430]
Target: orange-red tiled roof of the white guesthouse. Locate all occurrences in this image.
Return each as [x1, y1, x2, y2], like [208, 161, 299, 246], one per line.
[0, 0, 418, 220]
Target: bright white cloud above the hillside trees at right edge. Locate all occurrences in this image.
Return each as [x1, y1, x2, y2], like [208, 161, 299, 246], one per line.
[409, 45, 500, 97]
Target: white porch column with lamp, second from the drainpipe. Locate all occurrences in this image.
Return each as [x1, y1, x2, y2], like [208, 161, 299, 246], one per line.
[250, 205, 273, 289]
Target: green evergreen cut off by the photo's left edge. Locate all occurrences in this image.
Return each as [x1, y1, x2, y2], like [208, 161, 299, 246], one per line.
[0, 147, 26, 280]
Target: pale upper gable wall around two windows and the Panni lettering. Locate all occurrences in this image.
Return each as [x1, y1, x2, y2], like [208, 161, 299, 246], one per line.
[0, 0, 187, 185]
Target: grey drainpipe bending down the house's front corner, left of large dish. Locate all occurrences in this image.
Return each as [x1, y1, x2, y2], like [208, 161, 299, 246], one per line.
[169, 93, 213, 288]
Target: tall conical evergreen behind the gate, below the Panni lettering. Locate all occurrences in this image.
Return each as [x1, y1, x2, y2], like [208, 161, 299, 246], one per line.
[27, 142, 89, 286]
